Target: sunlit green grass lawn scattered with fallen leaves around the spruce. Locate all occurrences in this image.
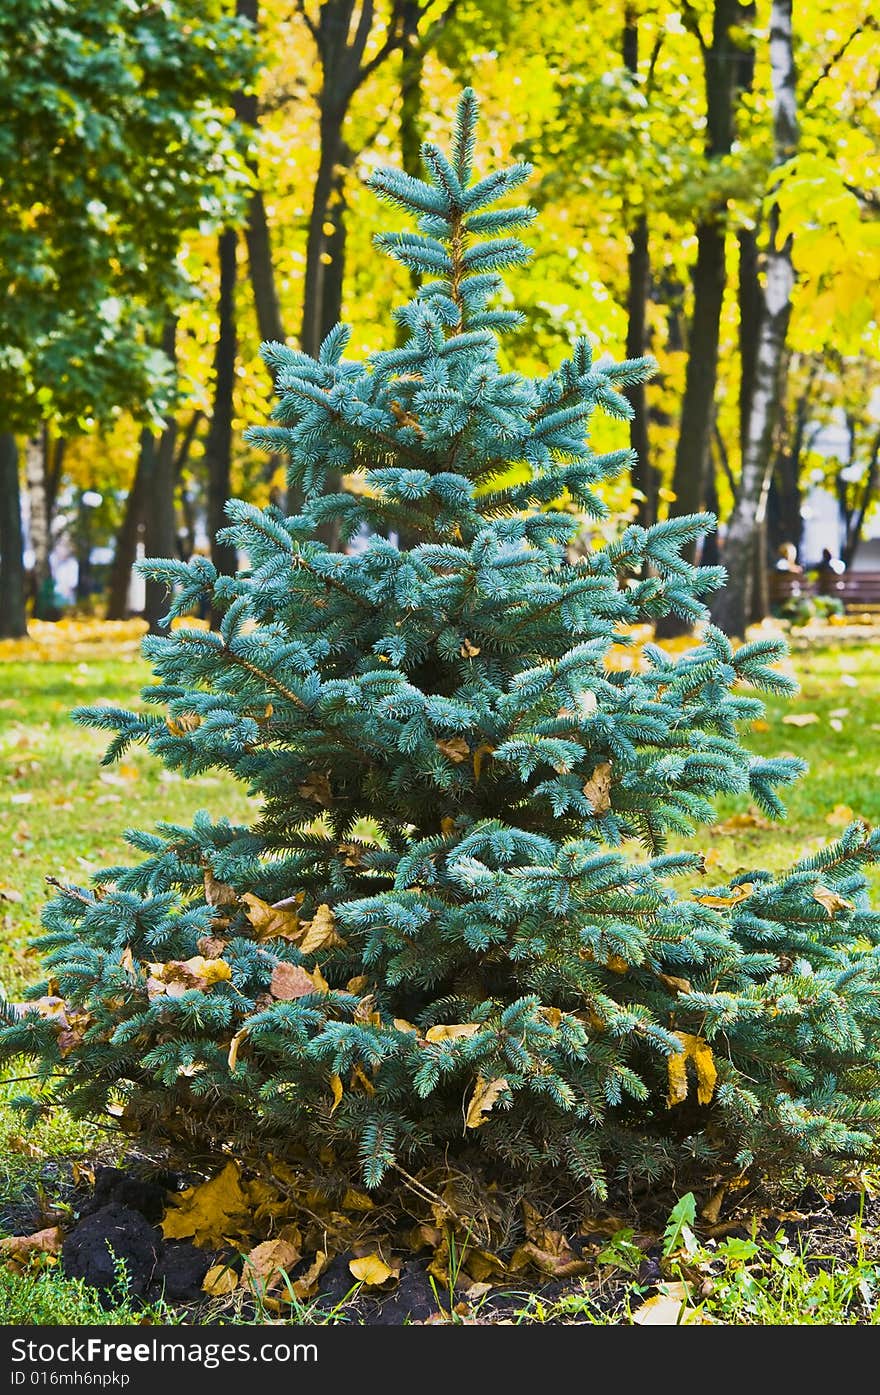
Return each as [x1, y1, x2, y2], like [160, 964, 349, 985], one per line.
[0, 626, 880, 1324]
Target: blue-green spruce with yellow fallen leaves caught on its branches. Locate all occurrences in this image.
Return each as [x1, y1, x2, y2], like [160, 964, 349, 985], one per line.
[0, 91, 880, 1196]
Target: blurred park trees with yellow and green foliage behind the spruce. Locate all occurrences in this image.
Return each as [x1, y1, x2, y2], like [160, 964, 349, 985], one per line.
[0, 0, 880, 635]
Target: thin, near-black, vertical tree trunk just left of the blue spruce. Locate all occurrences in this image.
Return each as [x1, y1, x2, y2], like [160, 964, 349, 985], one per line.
[205, 227, 237, 575]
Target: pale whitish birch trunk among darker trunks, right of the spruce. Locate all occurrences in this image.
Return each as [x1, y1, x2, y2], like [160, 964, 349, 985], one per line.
[713, 0, 798, 635]
